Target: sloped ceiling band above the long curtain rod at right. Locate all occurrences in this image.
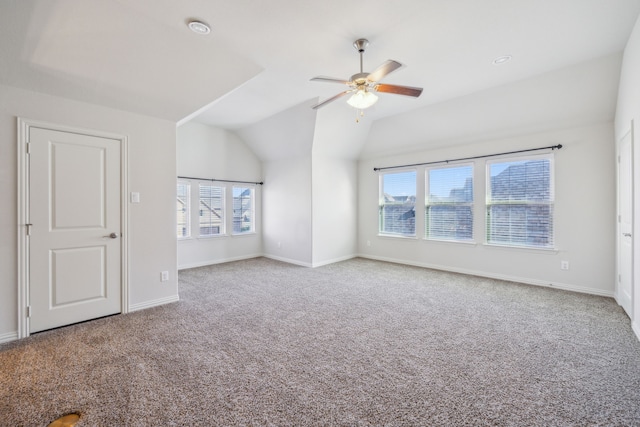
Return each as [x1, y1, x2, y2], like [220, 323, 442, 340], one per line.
[361, 53, 622, 158]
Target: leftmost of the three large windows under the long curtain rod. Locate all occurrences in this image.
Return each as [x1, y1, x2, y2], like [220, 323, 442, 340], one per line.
[379, 170, 416, 236]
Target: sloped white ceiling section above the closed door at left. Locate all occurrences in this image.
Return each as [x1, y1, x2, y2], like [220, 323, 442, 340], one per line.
[0, 0, 262, 122]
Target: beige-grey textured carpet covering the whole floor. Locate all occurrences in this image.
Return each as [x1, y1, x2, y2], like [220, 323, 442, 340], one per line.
[0, 258, 640, 426]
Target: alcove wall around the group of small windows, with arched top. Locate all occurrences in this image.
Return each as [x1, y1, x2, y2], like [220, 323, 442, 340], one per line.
[176, 122, 262, 269]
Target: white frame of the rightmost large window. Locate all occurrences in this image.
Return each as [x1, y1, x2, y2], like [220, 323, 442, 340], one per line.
[485, 153, 556, 251]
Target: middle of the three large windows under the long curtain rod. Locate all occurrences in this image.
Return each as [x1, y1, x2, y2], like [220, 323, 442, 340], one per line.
[425, 165, 473, 241]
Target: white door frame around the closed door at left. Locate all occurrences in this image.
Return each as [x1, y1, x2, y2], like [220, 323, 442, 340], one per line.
[17, 117, 129, 339]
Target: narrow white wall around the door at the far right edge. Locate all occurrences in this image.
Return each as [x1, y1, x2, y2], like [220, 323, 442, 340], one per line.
[615, 13, 640, 338]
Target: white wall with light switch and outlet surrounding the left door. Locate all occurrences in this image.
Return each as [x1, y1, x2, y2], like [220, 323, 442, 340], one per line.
[0, 85, 178, 341]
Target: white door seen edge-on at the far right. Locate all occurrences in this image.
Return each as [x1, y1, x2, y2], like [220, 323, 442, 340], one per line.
[616, 127, 633, 318]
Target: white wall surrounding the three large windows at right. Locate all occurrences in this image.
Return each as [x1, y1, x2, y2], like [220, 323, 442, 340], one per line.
[358, 123, 615, 296]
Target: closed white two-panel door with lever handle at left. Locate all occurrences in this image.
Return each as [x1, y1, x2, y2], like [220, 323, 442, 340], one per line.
[28, 127, 122, 332]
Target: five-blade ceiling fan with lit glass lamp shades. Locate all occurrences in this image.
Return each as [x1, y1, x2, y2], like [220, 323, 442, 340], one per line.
[311, 39, 422, 110]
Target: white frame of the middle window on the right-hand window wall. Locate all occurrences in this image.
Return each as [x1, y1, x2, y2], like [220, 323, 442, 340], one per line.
[423, 162, 476, 243]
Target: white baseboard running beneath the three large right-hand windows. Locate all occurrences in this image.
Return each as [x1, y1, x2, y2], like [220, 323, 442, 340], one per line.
[358, 255, 614, 298]
